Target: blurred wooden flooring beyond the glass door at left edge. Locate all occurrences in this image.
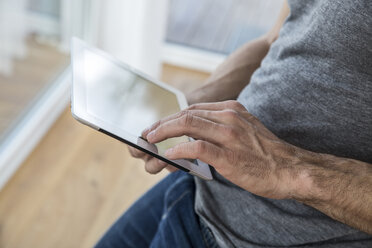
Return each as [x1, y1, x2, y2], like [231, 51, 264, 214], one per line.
[0, 36, 69, 139]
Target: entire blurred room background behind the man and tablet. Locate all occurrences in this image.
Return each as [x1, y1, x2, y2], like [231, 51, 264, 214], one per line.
[0, 0, 282, 248]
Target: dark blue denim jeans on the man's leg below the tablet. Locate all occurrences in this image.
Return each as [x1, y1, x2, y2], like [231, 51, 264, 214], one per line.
[96, 171, 217, 248]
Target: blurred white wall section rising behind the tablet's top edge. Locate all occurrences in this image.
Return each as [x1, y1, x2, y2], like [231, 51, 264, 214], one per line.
[98, 0, 168, 77]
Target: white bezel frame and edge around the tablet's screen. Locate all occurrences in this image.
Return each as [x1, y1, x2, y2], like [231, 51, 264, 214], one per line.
[71, 37, 213, 180]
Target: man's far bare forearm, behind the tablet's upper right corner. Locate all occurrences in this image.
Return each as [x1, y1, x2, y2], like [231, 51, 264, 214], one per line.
[187, 36, 270, 104]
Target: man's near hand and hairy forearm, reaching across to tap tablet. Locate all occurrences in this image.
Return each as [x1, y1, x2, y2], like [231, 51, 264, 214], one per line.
[142, 101, 372, 234]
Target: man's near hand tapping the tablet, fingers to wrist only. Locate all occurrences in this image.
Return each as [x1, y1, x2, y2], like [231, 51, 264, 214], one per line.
[142, 101, 293, 198]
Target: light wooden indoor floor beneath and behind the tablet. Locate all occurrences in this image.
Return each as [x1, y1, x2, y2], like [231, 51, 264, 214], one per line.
[0, 65, 208, 248]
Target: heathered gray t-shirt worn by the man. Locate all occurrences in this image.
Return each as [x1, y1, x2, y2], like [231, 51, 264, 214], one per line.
[195, 0, 372, 247]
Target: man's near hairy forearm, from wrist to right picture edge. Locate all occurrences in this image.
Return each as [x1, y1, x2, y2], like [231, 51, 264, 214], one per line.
[293, 148, 372, 234]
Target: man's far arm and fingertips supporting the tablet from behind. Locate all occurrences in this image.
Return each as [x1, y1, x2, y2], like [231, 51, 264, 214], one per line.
[129, 1, 289, 178]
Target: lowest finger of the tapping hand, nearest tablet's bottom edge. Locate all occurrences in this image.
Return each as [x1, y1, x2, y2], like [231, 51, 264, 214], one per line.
[165, 140, 223, 166]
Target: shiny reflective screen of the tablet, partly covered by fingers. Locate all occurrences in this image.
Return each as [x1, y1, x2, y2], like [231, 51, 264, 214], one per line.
[83, 49, 188, 155]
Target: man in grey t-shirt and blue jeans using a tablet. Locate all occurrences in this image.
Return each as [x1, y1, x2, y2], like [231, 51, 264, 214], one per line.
[97, 0, 372, 247]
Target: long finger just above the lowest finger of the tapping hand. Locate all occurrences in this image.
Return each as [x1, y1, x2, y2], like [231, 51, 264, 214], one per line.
[147, 114, 227, 144]
